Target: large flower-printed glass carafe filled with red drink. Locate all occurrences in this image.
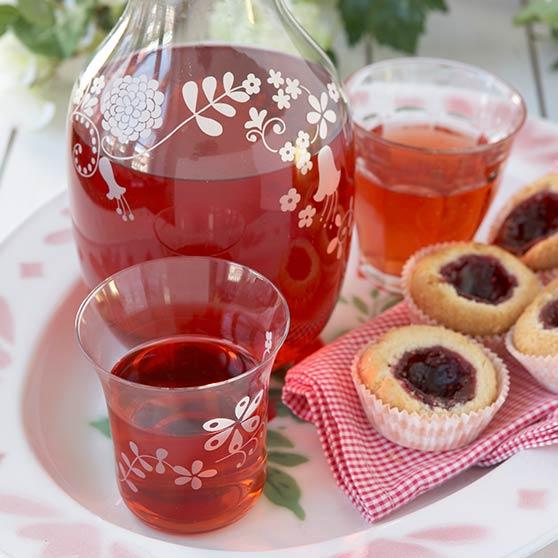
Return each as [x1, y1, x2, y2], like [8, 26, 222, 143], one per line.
[68, 0, 353, 363]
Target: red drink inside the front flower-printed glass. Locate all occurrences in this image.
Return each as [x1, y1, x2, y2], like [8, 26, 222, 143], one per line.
[109, 336, 267, 533]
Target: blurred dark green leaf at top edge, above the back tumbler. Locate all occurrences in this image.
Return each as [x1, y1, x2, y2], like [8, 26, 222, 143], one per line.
[339, 0, 447, 54]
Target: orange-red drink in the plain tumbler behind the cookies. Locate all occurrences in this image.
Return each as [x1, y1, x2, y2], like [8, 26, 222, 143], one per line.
[355, 124, 509, 275]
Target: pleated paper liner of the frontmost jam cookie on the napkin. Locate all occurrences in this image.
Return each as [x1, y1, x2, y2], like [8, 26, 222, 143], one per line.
[351, 346, 510, 451]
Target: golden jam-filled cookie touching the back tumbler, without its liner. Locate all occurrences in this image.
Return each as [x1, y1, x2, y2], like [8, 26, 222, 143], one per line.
[404, 242, 540, 336]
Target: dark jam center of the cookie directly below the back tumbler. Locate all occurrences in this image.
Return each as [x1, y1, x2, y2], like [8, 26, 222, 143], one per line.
[440, 254, 517, 304]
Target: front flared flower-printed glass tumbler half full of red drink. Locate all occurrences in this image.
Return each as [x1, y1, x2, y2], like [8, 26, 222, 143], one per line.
[76, 256, 289, 533]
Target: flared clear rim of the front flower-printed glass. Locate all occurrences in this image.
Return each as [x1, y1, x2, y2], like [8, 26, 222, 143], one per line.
[74, 256, 291, 394]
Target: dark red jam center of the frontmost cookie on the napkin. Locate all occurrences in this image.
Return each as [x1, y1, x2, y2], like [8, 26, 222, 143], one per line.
[394, 345, 475, 409]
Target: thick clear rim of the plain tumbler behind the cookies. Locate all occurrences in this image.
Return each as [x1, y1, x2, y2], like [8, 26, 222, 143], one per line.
[343, 56, 527, 155]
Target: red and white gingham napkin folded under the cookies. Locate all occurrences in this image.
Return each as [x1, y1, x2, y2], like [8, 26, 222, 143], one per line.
[283, 303, 558, 521]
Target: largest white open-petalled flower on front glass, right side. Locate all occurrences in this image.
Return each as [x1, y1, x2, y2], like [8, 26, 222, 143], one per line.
[203, 389, 264, 469]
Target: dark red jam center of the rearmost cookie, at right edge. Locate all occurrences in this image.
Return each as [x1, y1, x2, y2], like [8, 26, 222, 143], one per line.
[494, 192, 558, 256]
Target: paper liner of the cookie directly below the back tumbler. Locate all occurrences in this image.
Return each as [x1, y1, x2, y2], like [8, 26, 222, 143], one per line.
[401, 242, 506, 352]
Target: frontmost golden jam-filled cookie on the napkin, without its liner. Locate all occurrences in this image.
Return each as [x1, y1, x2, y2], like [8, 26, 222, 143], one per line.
[357, 325, 498, 415]
